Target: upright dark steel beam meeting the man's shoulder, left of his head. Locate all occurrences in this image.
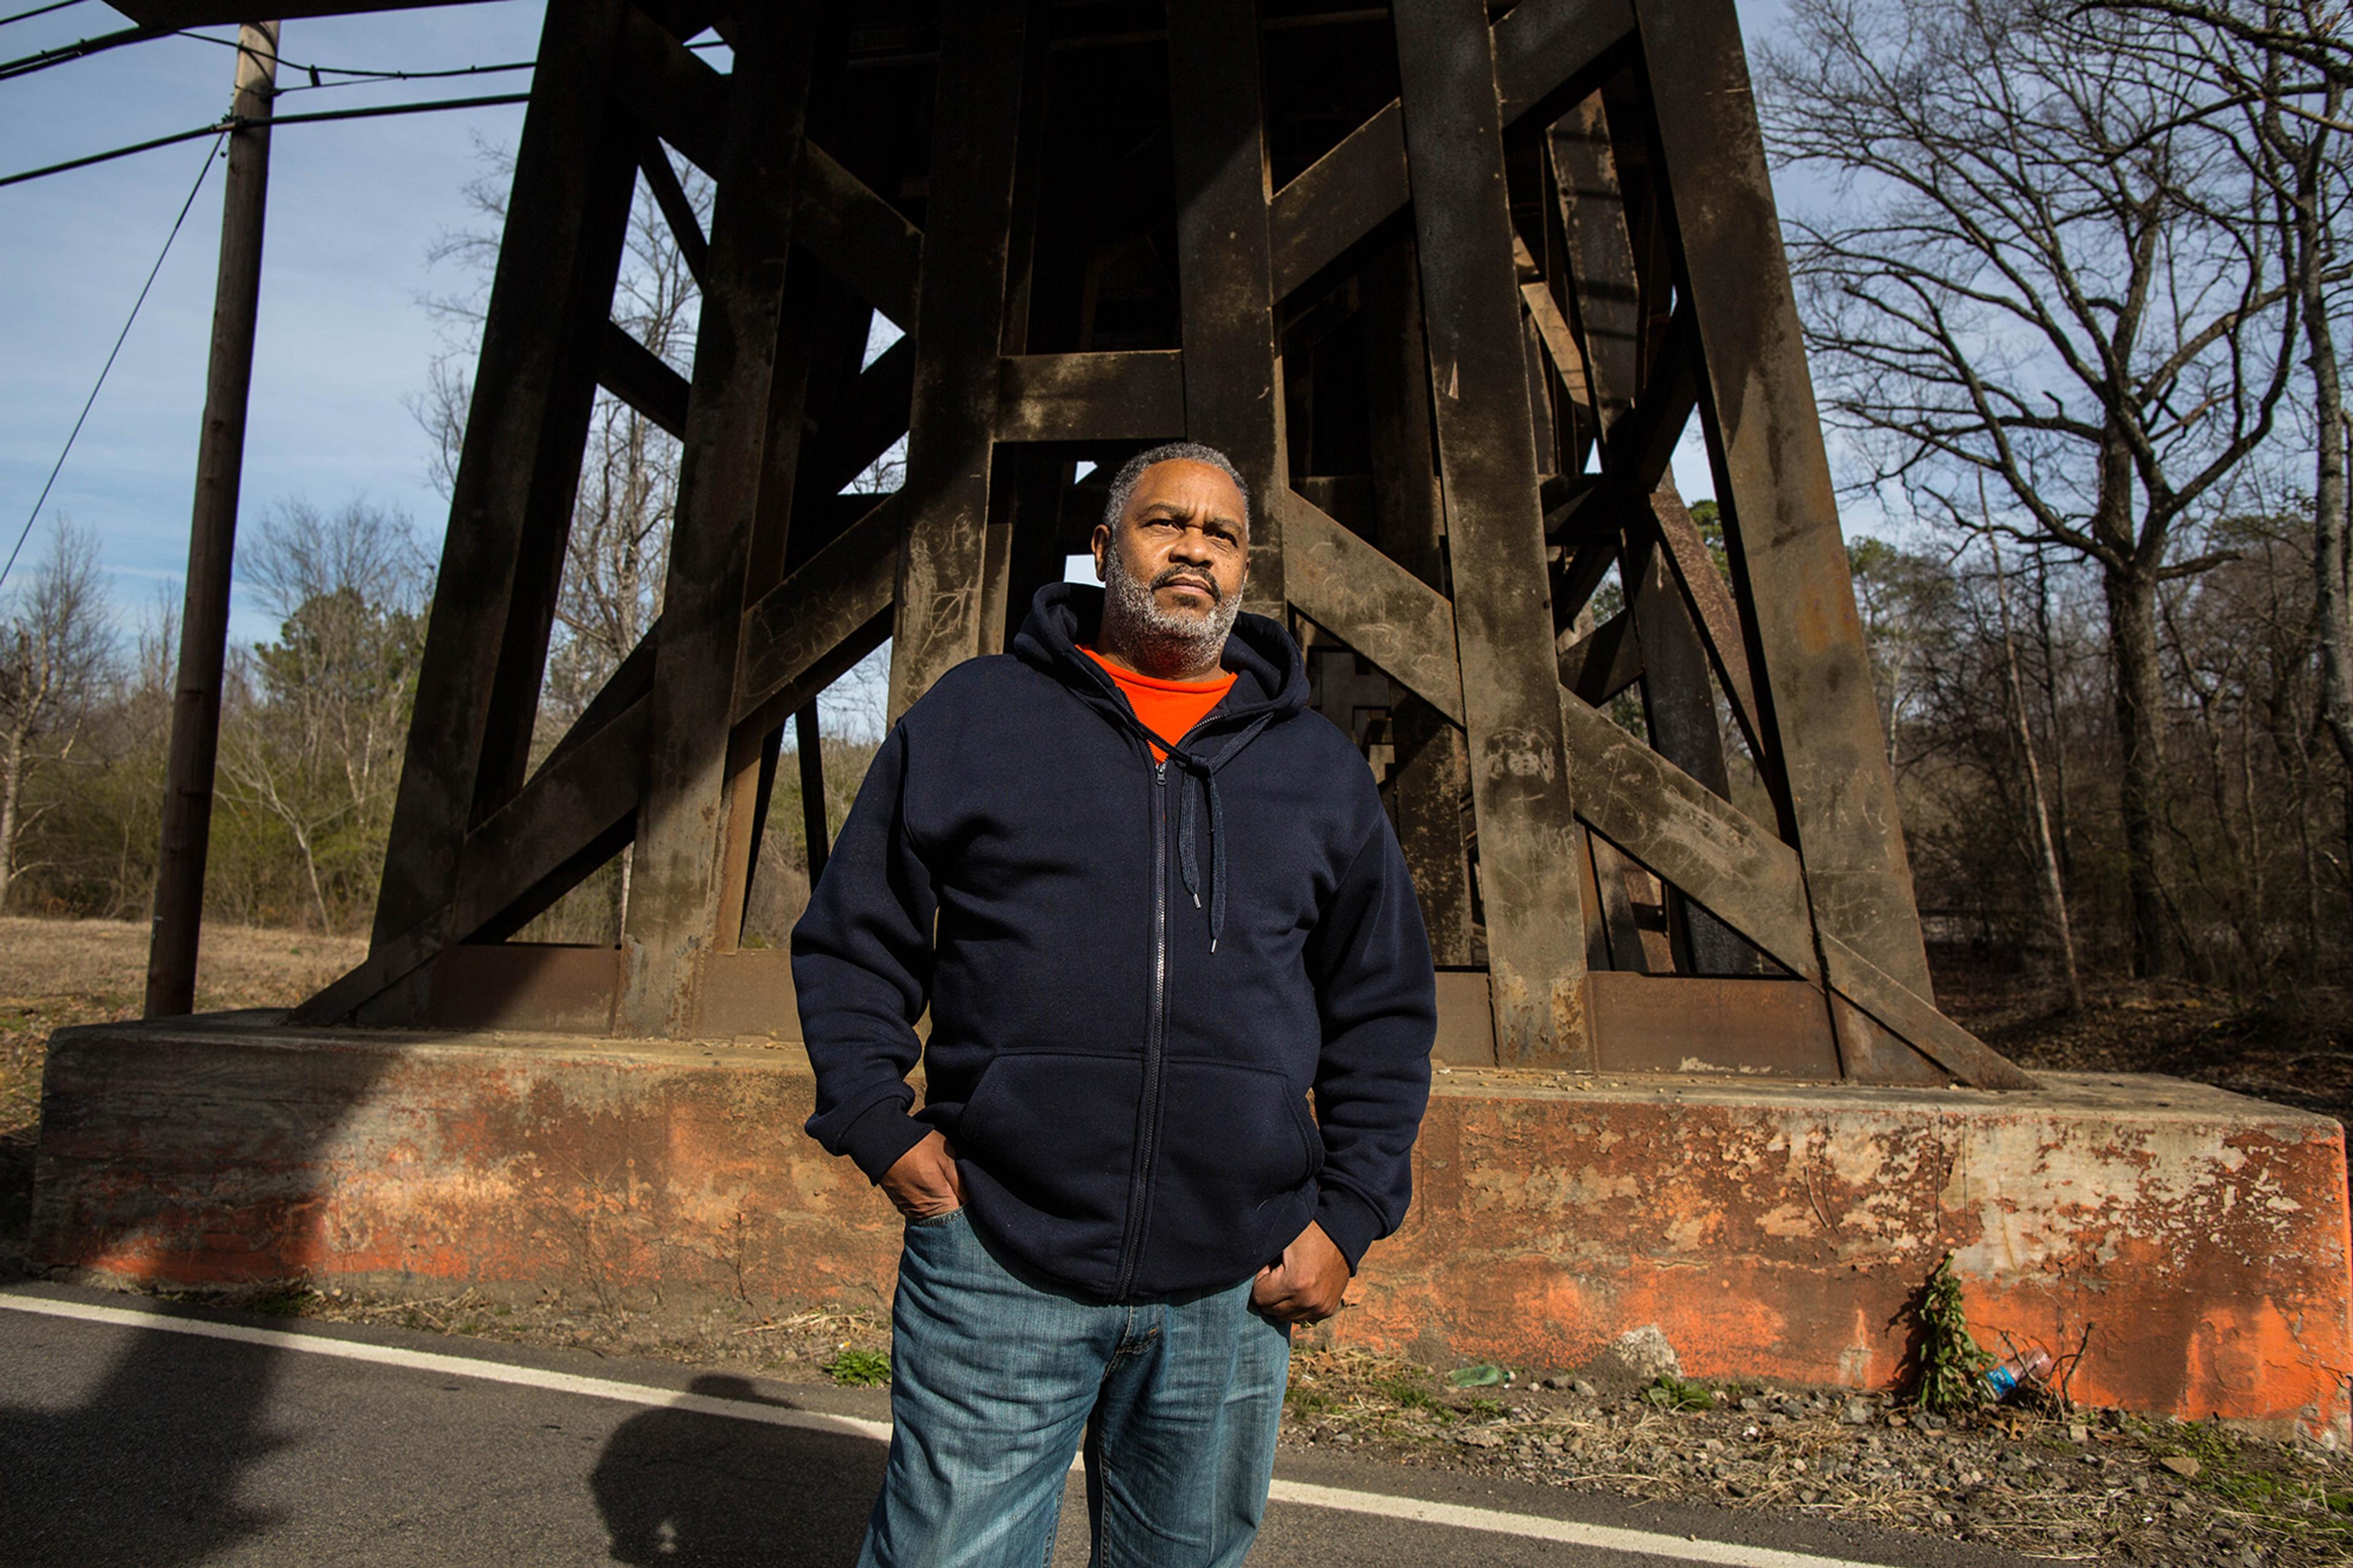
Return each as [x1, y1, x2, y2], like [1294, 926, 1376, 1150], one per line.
[890, 0, 1042, 723]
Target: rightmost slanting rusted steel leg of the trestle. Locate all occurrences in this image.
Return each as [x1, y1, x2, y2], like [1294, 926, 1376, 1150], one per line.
[1635, 0, 1932, 993]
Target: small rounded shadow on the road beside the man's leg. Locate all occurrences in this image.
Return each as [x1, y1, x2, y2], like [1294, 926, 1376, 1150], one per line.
[588, 1375, 882, 1568]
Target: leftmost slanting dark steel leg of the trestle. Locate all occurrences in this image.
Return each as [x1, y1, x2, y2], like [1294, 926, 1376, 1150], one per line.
[374, 0, 638, 1017]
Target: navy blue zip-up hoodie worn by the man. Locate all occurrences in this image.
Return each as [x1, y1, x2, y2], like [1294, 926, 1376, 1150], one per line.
[793, 584, 1438, 1302]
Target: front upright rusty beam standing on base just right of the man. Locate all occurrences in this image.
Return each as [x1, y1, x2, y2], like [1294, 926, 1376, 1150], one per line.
[1395, 0, 1593, 1067]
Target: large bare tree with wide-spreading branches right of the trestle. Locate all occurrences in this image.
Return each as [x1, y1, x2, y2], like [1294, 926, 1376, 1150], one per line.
[1760, 0, 2299, 972]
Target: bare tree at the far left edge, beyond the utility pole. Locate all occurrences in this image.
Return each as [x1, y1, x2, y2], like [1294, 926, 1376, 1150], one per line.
[0, 518, 108, 909]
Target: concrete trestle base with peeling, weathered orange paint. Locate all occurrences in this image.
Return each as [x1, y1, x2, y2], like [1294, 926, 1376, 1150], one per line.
[33, 1015, 2353, 1441]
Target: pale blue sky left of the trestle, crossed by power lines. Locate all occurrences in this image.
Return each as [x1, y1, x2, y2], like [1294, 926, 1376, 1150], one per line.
[0, 0, 1784, 640]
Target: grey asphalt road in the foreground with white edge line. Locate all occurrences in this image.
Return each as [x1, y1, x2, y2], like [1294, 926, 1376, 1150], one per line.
[0, 1286, 2023, 1568]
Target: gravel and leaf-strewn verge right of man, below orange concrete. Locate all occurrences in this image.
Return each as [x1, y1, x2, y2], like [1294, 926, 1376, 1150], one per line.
[1285, 1352, 2353, 1568]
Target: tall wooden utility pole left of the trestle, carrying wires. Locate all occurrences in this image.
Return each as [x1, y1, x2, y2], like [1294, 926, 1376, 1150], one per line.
[146, 21, 278, 1017]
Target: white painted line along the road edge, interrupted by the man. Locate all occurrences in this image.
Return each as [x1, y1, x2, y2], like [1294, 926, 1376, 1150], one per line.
[0, 1292, 1885, 1568]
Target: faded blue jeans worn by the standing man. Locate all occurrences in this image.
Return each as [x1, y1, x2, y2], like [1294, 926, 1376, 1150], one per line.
[859, 1210, 1292, 1568]
